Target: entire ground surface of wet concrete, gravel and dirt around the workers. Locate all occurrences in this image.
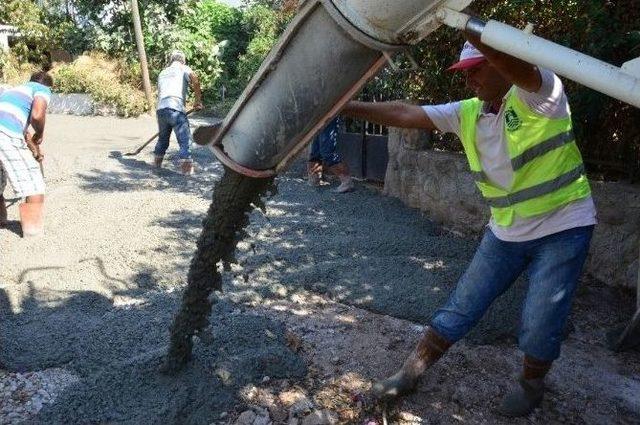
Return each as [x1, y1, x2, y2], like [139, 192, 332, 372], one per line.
[0, 115, 640, 425]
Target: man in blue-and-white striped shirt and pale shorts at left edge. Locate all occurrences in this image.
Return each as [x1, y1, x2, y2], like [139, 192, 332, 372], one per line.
[0, 72, 53, 236]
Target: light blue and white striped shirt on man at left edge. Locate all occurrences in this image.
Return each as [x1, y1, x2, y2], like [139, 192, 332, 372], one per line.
[0, 81, 51, 139]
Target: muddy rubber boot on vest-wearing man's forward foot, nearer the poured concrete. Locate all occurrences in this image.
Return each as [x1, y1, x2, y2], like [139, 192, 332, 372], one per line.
[371, 329, 452, 400]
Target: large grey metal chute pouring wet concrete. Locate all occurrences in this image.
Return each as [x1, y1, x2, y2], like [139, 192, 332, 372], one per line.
[200, 0, 471, 177]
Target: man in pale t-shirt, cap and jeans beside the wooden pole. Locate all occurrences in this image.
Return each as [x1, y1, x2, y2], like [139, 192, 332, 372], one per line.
[153, 50, 202, 174]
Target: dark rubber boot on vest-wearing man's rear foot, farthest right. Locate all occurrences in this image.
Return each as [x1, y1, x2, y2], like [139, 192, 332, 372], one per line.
[498, 356, 551, 418]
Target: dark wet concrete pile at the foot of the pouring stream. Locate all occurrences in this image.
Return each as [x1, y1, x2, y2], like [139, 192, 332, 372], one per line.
[0, 293, 306, 424]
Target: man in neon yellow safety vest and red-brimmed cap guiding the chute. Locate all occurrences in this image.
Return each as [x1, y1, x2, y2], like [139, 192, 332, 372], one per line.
[344, 35, 596, 417]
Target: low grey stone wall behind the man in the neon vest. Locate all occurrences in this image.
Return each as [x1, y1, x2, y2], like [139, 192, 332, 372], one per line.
[384, 129, 640, 288]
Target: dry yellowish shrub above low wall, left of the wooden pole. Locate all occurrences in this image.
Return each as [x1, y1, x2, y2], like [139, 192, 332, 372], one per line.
[51, 53, 147, 117]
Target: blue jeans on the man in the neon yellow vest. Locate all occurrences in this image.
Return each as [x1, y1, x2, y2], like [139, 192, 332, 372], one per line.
[431, 226, 594, 361]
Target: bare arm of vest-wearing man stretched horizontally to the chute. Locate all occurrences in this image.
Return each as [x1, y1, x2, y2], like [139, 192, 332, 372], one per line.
[342, 101, 435, 130]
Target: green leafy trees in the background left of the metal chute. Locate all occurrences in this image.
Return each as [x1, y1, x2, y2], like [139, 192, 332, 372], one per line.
[0, 0, 295, 99]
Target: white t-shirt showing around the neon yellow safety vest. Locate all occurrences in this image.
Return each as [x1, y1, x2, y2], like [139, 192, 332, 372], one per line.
[423, 69, 597, 242]
